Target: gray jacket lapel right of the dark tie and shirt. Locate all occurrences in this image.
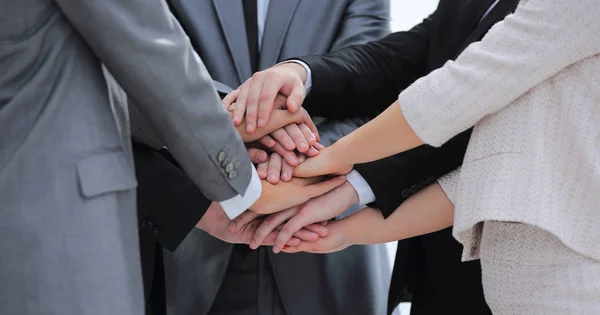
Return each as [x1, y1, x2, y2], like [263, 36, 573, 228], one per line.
[258, 0, 300, 69]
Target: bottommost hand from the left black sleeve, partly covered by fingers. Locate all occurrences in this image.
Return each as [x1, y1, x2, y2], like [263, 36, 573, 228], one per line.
[196, 202, 327, 246]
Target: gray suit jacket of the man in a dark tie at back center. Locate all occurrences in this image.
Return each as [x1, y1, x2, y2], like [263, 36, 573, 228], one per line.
[157, 0, 391, 315]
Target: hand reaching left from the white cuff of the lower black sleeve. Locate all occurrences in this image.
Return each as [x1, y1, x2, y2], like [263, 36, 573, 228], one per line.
[260, 182, 358, 253]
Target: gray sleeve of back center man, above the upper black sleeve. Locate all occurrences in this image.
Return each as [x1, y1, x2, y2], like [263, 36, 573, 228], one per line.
[329, 0, 390, 51]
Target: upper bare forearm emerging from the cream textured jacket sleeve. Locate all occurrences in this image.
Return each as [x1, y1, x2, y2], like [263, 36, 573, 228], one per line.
[330, 103, 423, 165]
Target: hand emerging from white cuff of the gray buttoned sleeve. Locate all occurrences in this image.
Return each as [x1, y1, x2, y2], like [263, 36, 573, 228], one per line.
[250, 176, 346, 214]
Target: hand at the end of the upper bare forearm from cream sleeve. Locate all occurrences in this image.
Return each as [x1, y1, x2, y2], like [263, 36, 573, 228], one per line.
[294, 145, 354, 177]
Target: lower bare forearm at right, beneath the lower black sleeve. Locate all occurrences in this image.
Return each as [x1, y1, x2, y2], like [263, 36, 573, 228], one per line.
[341, 184, 454, 245]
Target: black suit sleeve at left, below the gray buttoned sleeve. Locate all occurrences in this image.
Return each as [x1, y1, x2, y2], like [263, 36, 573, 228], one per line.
[133, 142, 212, 251]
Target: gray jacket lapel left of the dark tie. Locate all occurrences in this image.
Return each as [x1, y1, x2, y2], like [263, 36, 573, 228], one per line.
[212, 0, 251, 82]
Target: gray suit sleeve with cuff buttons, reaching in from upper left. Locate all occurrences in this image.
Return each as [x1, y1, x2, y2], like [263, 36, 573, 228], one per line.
[55, 0, 258, 202]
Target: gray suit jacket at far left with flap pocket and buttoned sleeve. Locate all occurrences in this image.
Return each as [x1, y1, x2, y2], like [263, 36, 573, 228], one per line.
[0, 0, 251, 315]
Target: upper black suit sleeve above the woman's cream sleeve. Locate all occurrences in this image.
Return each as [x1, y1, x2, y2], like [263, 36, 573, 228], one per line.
[297, 15, 434, 119]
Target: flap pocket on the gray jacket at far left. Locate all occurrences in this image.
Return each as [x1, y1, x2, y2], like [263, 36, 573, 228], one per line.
[77, 151, 137, 198]
